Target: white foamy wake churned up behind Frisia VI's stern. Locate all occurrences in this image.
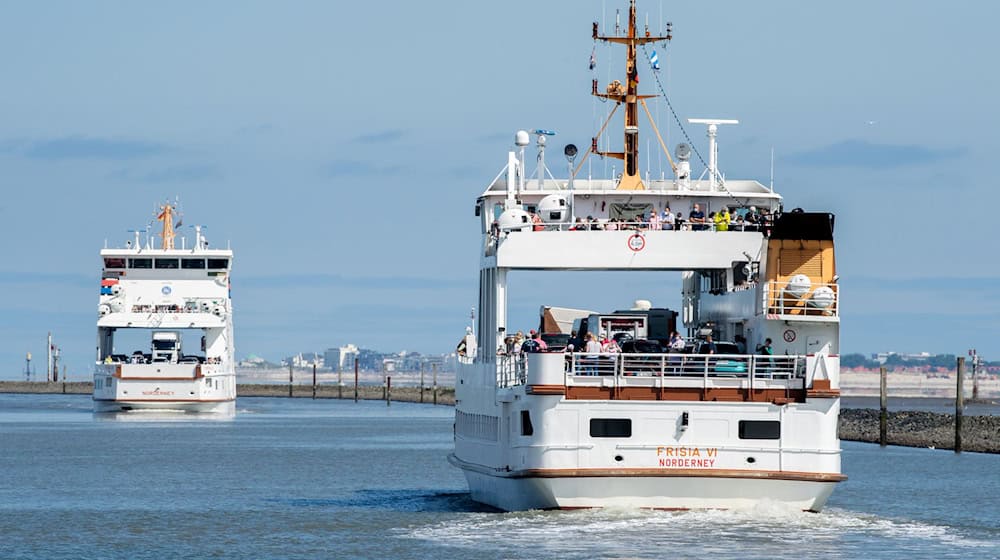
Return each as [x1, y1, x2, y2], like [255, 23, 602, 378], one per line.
[399, 502, 997, 558]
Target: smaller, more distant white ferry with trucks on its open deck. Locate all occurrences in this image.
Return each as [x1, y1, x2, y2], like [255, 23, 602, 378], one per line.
[94, 203, 236, 414]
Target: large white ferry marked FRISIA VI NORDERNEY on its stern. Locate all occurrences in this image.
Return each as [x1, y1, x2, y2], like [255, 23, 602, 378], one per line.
[449, 0, 846, 511]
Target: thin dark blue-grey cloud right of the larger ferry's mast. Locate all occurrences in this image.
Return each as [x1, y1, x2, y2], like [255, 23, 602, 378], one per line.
[782, 140, 967, 169]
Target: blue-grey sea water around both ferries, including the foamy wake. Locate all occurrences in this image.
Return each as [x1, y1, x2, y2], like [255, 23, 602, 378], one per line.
[0, 395, 1000, 559]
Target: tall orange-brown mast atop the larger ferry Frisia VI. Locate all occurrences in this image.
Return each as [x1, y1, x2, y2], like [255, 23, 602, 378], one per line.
[590, 0, 671, 190]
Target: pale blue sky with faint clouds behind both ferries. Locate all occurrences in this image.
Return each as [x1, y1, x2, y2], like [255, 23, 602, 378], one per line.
[0, 0, 1000, 378]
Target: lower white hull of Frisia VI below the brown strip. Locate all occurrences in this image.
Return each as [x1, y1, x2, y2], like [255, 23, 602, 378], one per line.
[449, 455, 841, 512]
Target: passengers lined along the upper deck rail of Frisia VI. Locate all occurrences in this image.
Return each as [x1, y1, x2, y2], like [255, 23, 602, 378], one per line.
[531, 204, 773, 233]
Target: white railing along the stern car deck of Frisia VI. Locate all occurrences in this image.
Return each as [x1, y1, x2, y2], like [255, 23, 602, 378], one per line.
[497, 352, 806, 387]
